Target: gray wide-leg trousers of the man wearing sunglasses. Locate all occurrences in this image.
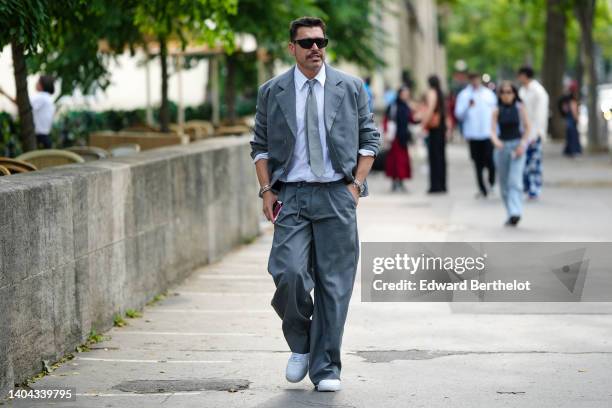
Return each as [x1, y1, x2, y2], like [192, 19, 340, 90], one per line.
[268, 181, 359, 384]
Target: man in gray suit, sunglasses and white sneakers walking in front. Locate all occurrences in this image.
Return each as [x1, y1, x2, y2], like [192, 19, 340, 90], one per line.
[251, 17, 380, 391]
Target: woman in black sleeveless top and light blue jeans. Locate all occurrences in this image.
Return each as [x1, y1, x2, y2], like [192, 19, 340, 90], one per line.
[491, 81, 530, 226]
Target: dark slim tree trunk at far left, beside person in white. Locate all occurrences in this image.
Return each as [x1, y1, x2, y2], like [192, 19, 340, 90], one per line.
[11, 42, 36, 152]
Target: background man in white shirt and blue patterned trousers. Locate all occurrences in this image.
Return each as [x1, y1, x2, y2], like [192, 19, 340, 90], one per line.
[518, 66, 548, 200]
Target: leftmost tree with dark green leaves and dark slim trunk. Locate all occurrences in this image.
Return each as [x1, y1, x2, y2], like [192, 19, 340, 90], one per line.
[0, 0, 138, 151]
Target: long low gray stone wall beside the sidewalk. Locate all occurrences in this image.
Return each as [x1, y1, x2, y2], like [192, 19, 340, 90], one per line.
[0, 137, 260, 397]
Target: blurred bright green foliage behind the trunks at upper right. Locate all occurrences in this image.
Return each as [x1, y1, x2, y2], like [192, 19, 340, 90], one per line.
[438, 0, 612, 77]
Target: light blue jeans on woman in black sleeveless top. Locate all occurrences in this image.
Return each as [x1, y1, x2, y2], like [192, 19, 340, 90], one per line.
[494, 139, 526, 217]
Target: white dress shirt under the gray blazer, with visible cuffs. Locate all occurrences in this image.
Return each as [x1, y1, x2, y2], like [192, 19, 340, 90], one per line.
[253, 64, 374, 182]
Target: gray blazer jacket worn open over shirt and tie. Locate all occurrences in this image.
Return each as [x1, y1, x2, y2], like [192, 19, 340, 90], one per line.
[251, 65, 380, 196]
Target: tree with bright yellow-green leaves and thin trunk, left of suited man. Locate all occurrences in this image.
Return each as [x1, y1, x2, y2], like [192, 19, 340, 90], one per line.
[134, 0, 237, 132]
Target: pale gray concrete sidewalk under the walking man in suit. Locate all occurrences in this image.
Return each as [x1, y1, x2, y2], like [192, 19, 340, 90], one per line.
[9, 139, 612, 408]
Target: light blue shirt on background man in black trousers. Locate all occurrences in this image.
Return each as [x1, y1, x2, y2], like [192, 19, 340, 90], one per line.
[455, 85, 497, 140]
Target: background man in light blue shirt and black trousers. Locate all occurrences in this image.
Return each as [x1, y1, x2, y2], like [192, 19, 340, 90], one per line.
[455, 73, 497, 198]
